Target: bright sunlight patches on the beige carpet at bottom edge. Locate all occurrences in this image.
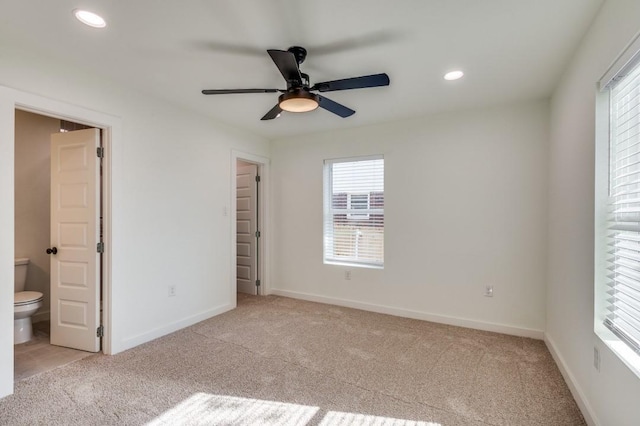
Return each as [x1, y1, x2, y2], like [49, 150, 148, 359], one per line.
[147, 392, 442, 426]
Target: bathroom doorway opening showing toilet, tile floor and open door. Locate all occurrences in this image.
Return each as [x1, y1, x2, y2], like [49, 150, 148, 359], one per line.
[14, 109, 102, 381]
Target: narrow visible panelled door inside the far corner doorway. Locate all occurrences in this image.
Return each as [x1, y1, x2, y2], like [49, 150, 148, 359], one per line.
[236, 163, 258, 294]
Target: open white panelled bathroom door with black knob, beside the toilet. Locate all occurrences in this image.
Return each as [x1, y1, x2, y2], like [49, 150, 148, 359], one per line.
[50, 129, 100, 352]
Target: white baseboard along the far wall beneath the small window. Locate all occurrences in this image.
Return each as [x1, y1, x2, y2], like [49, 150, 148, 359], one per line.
[269, 289, 544, 340]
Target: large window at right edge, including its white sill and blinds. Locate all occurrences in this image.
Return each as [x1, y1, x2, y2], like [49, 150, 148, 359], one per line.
[595, 36, 640, 375]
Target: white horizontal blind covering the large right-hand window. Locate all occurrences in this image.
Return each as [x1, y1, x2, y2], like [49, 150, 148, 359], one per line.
[604, 57, 640, 353]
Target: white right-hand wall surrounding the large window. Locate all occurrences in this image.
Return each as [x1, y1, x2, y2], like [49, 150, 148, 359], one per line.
[546, 0, 640, 426]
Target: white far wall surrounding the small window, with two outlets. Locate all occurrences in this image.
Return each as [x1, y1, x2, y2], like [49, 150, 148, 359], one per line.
[272, 102, 549, 338]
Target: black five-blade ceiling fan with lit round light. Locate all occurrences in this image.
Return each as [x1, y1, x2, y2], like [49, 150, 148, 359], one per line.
[202, 46, 389, 120]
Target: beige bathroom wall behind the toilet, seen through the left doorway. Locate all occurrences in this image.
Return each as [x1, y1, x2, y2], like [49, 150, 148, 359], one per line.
[15, 111, 60, 322]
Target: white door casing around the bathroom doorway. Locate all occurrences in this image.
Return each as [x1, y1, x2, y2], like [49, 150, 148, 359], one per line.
[0, 86, 116, 395]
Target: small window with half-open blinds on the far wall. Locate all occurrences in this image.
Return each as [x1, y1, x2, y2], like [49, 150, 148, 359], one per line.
[324, 156, 384, 267]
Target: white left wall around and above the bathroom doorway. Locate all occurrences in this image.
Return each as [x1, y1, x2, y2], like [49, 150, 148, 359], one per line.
[0, 42, 269, 397]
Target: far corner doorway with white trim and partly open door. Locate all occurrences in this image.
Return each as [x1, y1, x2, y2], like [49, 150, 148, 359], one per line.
[231, 152, 269, 295]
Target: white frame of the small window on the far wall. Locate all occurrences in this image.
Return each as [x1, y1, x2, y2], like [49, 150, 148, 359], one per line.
[322, 155, 385, 269]
